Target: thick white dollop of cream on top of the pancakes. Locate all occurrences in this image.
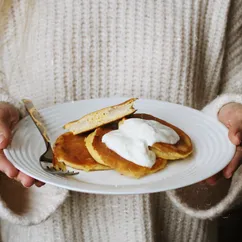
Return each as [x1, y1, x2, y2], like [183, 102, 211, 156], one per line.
[102, 118, 180, 168]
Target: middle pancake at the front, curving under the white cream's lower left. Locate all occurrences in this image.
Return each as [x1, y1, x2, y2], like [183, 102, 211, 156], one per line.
[85, 126, 167, 178]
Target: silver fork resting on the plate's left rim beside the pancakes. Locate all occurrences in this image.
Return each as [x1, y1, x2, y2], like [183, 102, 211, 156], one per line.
[22, 99, 79, 176]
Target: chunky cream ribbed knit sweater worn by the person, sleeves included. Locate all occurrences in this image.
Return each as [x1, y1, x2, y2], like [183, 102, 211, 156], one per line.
[0, 0, 242, 242]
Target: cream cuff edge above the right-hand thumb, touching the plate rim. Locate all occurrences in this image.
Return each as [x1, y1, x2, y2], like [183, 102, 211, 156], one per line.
[202, 93, 242, 118]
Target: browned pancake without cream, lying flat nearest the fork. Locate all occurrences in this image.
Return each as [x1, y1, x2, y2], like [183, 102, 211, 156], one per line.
[53, 132, 110, 171]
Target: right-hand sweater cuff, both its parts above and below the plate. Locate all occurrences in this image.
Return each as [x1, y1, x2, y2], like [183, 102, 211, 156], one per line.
[167, 94, 242, 219]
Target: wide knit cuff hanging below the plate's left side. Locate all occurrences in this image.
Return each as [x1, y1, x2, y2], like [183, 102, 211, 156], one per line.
[0, 175, 68, 225]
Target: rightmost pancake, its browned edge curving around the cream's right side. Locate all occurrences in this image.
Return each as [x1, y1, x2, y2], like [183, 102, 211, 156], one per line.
[130, 114, 193, 160]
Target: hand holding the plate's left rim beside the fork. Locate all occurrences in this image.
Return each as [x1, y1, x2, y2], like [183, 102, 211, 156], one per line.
[0, 102, 43, 187]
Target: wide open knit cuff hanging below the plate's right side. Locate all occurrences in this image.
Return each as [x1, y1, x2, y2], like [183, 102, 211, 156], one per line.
[167, 166, 242, 219]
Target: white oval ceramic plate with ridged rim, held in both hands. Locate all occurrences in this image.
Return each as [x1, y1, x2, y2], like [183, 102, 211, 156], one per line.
[4, 98, 235, 194]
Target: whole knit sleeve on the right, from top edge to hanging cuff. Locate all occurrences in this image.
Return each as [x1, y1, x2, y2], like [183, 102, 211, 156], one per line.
[167, 0, 242, 219]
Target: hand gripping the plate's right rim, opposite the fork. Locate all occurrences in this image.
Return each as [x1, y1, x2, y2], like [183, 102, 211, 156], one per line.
[206, 103, 242, 185]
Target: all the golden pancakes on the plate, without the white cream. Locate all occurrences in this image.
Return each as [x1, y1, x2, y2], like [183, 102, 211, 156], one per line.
[54, 99, 193, 178]
